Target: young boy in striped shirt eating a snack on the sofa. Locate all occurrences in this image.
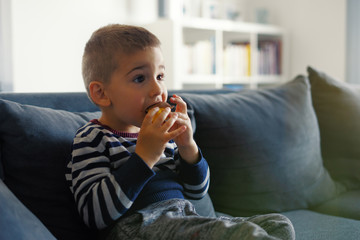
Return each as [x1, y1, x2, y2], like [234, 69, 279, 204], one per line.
[67, 24, 294, 240]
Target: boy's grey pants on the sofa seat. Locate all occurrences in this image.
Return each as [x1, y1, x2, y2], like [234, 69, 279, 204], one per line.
[106, 199, 295, 240]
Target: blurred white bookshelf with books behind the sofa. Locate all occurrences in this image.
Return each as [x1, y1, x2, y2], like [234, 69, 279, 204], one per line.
[145, 17, 287, 89]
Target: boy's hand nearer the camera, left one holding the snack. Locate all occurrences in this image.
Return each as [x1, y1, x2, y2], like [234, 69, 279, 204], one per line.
[135, 107, 186, 168]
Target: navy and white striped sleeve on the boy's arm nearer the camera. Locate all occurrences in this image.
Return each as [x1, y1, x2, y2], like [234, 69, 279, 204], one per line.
[71, 125, 155, 229]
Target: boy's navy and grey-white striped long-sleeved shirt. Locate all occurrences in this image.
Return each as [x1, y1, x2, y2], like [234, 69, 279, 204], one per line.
[66, 120, 209, 229]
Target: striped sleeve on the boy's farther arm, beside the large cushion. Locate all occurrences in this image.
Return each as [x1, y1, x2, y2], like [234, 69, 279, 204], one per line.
[179, 150, 210, 199]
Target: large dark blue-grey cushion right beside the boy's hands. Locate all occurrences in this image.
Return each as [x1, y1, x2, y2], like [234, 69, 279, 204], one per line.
[181, 76, 340, 216]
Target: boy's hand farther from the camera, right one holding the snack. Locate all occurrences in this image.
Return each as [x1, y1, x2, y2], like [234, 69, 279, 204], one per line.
[170, 94, 199, 164]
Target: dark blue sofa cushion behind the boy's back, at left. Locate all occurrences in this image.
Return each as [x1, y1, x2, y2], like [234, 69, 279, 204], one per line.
[0, 99, 99, 239]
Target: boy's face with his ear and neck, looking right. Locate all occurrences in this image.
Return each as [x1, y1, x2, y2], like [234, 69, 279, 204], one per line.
[100, 47, 167, 132]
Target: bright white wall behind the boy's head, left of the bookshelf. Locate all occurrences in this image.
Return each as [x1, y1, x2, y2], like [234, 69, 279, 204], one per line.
[11, 0, 156, 92]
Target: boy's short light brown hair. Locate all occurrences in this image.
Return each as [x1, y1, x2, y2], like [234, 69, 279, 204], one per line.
[82, 24, 160, 94]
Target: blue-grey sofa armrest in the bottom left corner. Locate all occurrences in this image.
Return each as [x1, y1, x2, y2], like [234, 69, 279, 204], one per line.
[0, 180, 55, 240]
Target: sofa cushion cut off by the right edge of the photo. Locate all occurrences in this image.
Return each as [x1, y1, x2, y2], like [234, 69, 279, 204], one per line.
[307, 67, 360, 189]
